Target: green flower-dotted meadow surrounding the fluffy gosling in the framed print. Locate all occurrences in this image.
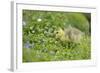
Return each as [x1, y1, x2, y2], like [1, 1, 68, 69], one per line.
[22, 10, 91, 62]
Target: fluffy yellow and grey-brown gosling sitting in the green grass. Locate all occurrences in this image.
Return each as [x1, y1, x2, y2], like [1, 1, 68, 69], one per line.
[55, 25, 84, 43]
